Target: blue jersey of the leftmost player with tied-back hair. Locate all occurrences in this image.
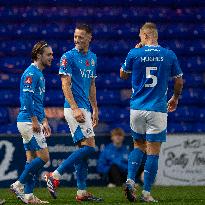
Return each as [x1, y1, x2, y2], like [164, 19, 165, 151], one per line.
[17, 63, 45, 123]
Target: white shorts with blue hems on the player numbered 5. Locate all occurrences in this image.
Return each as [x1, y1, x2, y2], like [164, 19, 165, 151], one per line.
[130, 109, 167, 142]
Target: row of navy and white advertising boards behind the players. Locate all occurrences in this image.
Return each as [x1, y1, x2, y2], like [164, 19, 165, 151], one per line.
[0, 135, 205, 187]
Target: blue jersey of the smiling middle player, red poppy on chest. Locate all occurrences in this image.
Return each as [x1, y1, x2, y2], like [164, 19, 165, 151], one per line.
[59, 48, 97, 111]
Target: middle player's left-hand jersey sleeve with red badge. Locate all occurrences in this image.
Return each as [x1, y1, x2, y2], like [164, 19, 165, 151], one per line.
[59, 54, 72, 76]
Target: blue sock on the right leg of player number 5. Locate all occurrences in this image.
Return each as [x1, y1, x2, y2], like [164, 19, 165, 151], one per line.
[144, 155, 159, 192]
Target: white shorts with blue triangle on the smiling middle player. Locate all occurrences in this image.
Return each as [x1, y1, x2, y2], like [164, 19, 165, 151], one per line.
[64, 108, 95, 143]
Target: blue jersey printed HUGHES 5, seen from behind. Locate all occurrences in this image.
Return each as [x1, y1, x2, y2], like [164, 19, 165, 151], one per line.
[122, 45, 182, 113]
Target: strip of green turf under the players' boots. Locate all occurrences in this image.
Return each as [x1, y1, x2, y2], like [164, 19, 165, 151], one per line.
[0, 187, 205, 205]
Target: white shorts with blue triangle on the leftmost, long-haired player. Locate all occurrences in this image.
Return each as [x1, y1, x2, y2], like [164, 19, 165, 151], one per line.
[17, 122, 47, 151]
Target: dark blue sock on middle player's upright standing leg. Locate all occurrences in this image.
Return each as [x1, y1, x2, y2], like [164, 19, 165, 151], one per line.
[75, 159, 88, 190]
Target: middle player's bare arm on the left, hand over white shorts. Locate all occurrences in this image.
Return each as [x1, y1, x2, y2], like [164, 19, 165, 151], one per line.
[61, 75, 85, 123]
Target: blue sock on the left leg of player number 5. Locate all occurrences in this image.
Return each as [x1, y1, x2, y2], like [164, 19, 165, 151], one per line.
[127, 148, 144, 181]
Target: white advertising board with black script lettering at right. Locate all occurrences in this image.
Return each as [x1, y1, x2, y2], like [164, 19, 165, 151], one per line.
[156, 134, 205, 186]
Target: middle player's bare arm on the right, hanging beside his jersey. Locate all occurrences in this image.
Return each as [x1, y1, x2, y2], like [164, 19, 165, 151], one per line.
[89, 78, 98, 127]
